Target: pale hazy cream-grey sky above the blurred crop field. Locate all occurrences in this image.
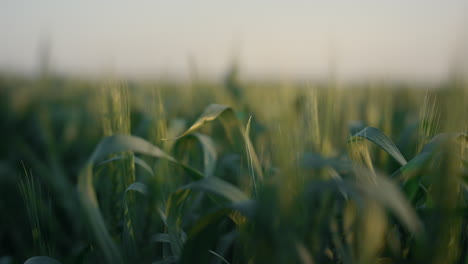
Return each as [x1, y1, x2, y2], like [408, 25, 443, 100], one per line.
[0, 0, 468, 80]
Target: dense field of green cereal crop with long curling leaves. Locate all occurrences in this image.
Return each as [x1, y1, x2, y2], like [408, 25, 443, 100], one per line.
[0, 76, 468, 264]
